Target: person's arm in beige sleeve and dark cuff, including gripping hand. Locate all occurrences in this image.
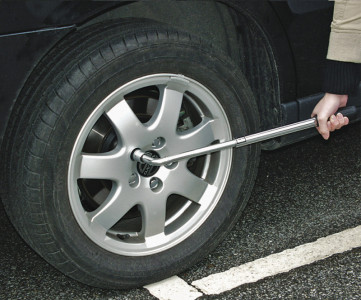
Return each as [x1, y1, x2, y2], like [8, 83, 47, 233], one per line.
[312, 0, 361, 139]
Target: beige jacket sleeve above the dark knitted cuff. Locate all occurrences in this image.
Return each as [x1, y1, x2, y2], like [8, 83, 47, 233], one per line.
[327, 0, 361, 63]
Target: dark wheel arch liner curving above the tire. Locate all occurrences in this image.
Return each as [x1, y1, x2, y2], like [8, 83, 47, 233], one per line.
[82, 0, 295, 134]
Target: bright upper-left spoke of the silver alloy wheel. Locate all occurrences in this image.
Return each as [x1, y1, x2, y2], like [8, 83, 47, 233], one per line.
[106, 100, 148, 144]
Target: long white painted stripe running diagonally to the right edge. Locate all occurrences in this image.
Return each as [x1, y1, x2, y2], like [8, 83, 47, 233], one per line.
[192, 226, 361, 295]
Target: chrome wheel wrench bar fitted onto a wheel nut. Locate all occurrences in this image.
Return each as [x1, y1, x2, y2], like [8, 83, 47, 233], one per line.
[131, 107, 355, 166]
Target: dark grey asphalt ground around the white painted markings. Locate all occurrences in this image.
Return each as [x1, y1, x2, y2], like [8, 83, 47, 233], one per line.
[0, 123, 361, 299]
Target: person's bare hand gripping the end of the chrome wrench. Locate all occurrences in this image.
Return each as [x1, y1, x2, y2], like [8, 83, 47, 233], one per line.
[311, 93, 349, 140]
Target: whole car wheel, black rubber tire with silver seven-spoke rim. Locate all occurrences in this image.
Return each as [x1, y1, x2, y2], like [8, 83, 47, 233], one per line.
[2, 23, 260, 288]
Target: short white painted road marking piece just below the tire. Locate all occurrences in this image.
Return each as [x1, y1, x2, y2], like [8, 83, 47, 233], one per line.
[145, 276, 203, 300]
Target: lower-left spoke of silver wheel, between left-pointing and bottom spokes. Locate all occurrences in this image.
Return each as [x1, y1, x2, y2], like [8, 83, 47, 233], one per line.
[88, 187, 136, 230]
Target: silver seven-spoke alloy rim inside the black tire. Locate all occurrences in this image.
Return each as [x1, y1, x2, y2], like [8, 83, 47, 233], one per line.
[68, 74, 232, 256]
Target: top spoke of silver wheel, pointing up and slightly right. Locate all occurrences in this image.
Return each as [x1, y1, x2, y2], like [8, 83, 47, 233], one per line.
[147, 84, 185, 134]
